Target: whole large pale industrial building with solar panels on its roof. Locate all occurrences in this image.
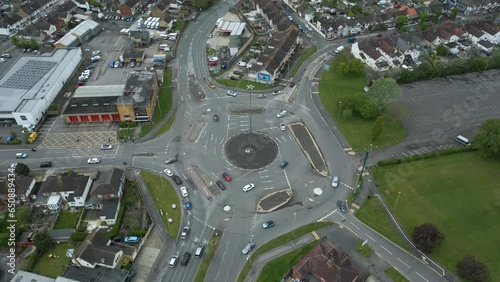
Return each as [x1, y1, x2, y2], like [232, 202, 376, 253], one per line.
[0, 48, 82, 125]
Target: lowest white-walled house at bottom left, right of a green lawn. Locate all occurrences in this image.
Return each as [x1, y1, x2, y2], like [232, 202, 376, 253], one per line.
[72, 231, 123, 268]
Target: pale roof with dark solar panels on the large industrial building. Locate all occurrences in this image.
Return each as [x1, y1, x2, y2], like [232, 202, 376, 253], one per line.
[0, 48, 81, 115]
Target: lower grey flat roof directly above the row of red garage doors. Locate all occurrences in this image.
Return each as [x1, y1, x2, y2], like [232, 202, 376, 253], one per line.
[64, 96, 118, 115]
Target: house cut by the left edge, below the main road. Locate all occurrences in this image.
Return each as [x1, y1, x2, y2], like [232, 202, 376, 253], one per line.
[0, 175, 36, 205]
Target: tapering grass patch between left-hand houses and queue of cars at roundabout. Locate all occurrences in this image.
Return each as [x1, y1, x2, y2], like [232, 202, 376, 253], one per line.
[142, 170, 183, 239]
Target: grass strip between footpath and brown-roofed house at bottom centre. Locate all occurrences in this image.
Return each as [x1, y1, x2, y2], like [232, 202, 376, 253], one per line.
[257, 241, 318, 282]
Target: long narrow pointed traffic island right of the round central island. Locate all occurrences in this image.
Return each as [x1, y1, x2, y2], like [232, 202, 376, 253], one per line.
[288, 122, 329, 177]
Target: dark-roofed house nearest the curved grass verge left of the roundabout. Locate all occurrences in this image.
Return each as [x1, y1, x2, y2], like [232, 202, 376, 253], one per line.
[85, 167, 125, 225]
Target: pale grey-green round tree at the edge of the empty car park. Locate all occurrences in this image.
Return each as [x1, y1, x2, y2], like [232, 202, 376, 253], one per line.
[366, 77, 401, 110]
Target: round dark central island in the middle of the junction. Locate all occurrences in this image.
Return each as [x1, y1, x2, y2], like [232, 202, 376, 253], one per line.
[224, 132, 278, 170]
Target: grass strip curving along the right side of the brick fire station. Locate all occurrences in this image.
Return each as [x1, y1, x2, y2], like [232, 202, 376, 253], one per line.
[140, 70, 172, 137]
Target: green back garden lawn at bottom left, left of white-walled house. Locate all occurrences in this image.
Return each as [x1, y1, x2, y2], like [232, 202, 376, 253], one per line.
[33, 243, 75, 278]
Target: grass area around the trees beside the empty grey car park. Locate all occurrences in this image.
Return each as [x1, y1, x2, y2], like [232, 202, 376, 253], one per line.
[319, 57, 406, 151]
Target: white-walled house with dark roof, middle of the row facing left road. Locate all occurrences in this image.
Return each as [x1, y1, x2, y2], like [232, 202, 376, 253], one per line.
[39, 174, 92, 208]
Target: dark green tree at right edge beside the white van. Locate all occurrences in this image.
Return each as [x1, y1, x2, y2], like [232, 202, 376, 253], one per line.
[474, 119, 500, 157]
